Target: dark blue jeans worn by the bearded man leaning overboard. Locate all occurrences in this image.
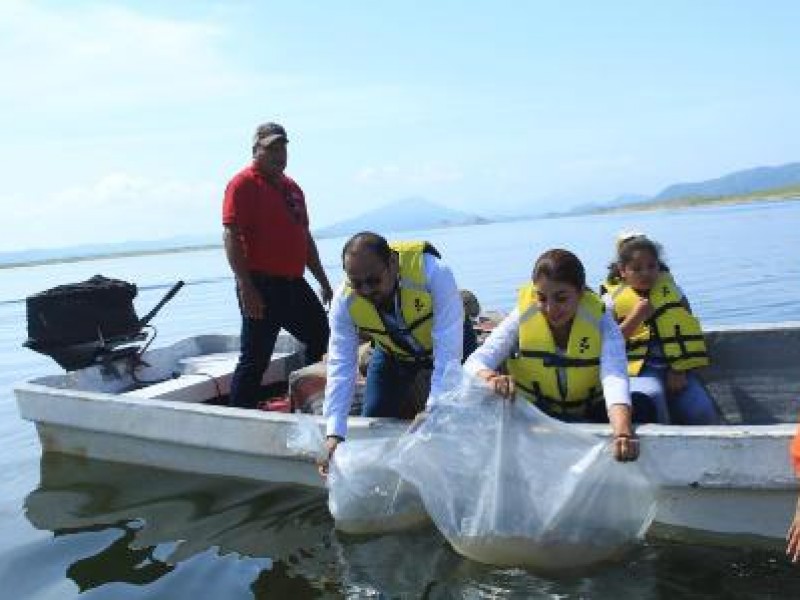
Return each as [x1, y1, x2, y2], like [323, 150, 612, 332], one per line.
[361, 319, 478, 419]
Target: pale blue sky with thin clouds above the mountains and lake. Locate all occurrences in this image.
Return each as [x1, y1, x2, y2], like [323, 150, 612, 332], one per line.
[0, 0, 800, 252]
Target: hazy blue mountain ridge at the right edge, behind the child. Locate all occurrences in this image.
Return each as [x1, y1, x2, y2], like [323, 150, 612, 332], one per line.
[650, 163, 800, 202]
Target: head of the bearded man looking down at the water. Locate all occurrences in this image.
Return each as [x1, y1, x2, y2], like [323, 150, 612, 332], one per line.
[342, 231, 400, 306]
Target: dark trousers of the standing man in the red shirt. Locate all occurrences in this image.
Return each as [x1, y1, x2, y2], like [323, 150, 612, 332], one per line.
[230, 274, 330, 408]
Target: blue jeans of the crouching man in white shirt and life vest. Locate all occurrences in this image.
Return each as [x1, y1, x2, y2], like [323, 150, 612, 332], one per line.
[361, 318, 478, 418]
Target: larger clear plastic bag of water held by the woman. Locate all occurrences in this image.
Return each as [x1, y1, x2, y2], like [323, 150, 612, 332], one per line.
[393, 368, 655, 569]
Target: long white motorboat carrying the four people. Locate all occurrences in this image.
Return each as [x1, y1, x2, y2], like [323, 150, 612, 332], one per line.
[14, 323, 800, 543]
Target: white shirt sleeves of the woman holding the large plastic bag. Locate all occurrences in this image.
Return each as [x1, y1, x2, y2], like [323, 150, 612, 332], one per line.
[464, 308, 631, 407]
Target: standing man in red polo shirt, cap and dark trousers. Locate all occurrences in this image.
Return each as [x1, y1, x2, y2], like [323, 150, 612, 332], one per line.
[222, 123, 333, 408]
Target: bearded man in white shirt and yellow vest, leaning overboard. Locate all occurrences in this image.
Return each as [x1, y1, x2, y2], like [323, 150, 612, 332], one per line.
[322, 232, 475, 471]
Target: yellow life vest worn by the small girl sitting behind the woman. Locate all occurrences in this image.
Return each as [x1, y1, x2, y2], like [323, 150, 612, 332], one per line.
[603, 272, 709, 376]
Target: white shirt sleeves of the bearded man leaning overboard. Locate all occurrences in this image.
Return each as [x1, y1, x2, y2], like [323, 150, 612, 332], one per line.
[322, 254, 464, 437]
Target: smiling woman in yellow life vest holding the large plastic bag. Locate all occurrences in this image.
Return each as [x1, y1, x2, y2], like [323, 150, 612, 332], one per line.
[464, 249, 647, 461]
